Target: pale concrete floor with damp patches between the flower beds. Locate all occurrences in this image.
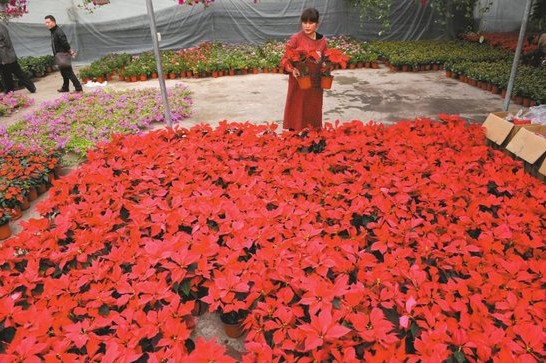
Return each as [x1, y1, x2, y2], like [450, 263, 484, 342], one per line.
[0, 67, 519, 356]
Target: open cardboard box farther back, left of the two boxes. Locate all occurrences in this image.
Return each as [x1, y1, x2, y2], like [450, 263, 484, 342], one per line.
[483, 112, 546, 145]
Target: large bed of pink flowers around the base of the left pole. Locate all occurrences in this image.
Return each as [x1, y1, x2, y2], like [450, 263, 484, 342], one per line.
[0, 84, 191, 157]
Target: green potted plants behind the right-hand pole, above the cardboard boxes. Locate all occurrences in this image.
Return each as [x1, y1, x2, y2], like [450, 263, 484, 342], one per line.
[445, 60, 546, 107]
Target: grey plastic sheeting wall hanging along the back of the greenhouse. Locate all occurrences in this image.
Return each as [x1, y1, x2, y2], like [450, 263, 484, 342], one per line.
[9, 0, 444, 63]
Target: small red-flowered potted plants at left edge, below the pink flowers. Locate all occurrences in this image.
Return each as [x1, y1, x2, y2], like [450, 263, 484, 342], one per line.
[0, 146, 60, 240]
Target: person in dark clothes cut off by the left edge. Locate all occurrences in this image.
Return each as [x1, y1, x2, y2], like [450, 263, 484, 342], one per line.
[0, 21, 36, 93]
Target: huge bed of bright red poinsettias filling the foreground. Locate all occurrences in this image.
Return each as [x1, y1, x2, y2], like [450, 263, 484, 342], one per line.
[0, 116, 546, 362]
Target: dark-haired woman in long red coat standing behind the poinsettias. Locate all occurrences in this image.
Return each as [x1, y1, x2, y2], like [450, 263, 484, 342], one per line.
[281, 8, 327, 130]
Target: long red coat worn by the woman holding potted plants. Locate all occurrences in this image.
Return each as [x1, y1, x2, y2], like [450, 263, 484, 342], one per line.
[281, 32, 327, 130]
